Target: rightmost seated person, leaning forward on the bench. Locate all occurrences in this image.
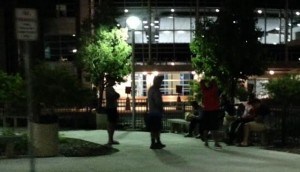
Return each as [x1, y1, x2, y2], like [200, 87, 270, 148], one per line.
[240, 100, 270, 146]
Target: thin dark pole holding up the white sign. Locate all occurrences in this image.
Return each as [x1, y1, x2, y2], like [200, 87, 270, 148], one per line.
[24, 41, 35, 172]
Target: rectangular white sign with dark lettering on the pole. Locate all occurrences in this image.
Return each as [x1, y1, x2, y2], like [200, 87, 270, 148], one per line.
[15, 8, 38, 41]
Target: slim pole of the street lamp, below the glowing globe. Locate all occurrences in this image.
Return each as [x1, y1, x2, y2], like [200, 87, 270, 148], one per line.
[131, 29, 136, 129]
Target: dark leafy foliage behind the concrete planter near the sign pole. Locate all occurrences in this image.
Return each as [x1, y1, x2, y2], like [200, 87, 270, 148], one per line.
[32, 64, 92, 108]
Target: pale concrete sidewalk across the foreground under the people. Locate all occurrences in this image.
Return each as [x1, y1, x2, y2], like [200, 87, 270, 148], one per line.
[0, 130, 300, 172]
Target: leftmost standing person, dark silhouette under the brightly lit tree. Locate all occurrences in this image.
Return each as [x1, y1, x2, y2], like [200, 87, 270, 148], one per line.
[105, 78, 120, 146]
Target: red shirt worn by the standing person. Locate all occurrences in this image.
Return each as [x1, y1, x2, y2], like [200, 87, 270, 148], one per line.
[200, 82, 220, 111]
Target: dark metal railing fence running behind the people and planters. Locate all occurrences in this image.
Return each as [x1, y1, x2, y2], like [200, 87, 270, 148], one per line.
[0, 99, 300, 146]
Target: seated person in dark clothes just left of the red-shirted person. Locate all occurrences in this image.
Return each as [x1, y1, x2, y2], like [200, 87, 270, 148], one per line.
[184, 101, 203, 138]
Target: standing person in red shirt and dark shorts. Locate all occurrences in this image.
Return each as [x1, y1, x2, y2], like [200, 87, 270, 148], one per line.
[200, 79, 221, 148]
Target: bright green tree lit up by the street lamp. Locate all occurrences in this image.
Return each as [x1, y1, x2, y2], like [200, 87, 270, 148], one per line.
[77, 26, 132, 108]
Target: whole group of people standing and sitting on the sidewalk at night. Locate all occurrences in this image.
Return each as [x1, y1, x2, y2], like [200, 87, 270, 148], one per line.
[102, 75, 269, 149]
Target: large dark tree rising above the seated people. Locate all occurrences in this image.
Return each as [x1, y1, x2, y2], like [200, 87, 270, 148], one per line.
[190, 0, 266, 99]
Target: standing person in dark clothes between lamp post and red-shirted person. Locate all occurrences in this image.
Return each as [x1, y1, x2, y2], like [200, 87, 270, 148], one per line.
[148, 75, 166, 149]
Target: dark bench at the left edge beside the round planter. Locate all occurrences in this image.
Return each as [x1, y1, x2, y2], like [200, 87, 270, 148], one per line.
[0, 136, 21, 158]
